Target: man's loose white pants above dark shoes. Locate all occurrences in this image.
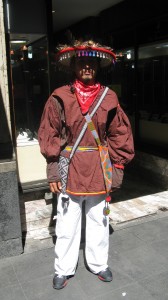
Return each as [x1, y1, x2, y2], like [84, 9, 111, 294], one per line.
[55, 194, 109, 275]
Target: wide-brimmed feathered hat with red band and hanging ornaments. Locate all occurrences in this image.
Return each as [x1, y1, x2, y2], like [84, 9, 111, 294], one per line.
[56, 40, 116, 69]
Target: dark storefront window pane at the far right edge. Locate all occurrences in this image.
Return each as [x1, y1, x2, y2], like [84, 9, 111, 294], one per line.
[138, 41, 168, 154]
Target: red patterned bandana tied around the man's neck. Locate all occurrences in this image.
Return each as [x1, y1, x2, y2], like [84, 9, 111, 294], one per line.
[74, 80, 100, 114]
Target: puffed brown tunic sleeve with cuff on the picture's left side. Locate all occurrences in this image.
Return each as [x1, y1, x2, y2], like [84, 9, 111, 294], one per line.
[38, 95, 61, 182]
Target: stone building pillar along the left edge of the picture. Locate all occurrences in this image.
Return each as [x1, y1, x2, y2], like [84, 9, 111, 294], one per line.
[0, 1, 23, 257]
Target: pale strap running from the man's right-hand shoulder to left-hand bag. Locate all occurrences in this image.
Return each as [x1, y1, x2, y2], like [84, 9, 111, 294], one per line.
[70, 87, 109, 159]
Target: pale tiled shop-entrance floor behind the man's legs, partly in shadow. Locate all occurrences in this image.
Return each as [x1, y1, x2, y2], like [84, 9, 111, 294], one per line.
[21, 169, 168, 252]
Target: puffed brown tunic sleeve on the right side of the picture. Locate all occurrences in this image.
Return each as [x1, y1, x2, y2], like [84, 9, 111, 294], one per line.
[107, 104, 134, 167]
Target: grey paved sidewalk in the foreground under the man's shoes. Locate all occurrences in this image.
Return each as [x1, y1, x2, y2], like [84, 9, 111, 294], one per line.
[0, 211, 168, 300]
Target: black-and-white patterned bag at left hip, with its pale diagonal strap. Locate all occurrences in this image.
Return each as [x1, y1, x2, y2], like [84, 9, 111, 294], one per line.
[58, 87, 108, 194]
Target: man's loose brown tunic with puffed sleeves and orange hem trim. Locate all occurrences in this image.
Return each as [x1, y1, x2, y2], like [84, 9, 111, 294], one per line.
[38, 85, 134, 195]
